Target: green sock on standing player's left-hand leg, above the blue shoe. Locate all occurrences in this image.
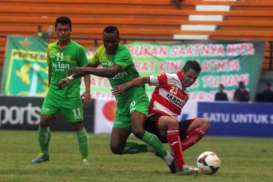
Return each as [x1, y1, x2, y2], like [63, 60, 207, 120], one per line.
[38, 127, 51, 156]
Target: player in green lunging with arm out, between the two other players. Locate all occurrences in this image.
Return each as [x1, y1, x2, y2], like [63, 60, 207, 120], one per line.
[60, 26, 175, 172]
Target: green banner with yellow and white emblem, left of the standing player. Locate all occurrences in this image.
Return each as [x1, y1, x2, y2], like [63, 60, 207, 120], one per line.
[2, 36, 48, 96]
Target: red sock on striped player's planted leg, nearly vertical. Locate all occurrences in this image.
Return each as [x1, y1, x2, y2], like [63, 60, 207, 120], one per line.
[167, 130, 184, 170]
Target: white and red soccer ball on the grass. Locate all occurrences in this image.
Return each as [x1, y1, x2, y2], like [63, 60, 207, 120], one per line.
[196, 151, 221, 174]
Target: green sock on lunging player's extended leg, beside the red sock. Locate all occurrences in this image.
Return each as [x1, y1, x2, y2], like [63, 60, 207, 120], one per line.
[142, 131, 167, 158]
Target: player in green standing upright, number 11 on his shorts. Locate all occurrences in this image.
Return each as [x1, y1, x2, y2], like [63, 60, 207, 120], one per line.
[32, 17, 90, 164]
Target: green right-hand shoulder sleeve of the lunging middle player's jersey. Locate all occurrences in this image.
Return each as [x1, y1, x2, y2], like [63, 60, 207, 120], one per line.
[114, 48, 133, 69]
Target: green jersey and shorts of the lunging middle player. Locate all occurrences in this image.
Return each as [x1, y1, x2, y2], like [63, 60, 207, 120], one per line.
[91, 45, 149, 128]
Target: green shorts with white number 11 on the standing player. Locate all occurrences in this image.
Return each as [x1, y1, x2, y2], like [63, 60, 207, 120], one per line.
[41, 86, 83, 123]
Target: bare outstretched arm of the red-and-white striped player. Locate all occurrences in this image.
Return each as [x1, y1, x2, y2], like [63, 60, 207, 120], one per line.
[112, 77, 149, 95]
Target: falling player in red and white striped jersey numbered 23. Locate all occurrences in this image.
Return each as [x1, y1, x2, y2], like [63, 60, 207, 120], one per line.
[113, 61, 208, 174]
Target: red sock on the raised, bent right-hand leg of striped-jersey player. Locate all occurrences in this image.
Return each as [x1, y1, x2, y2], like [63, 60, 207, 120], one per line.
[182, 128, 206, 151]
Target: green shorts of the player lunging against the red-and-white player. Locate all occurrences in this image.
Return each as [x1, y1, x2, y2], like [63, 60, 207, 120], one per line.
[113, 90, 149, 128]
